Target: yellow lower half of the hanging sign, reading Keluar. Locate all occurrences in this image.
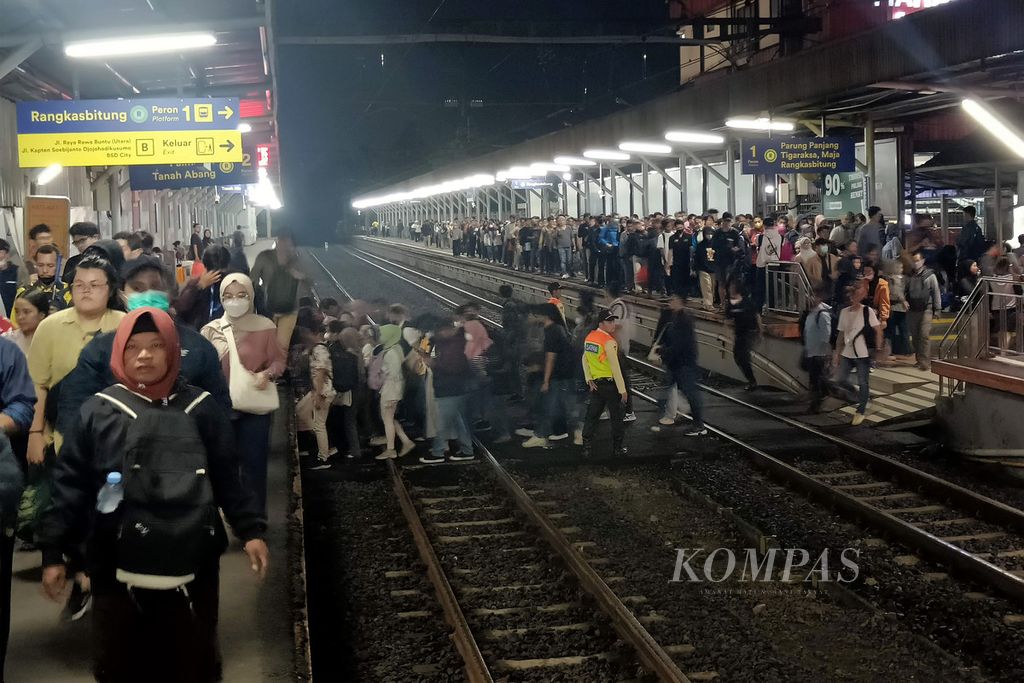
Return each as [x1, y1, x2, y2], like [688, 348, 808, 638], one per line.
[17, 130, 242, 168]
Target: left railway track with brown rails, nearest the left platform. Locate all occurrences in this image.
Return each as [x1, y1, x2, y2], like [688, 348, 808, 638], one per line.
[313, 255, 700, 683]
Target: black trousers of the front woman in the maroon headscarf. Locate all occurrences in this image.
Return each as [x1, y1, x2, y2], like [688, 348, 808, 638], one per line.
[92, 563, 221, 683]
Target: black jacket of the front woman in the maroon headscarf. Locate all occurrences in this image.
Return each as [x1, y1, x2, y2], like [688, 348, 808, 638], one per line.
[37, 382, 266, 569]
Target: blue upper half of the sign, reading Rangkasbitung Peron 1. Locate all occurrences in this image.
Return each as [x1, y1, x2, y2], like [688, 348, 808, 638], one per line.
[17, 97, 239, 135]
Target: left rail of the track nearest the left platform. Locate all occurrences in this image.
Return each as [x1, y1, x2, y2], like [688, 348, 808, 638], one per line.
[387, 460, 494, 683]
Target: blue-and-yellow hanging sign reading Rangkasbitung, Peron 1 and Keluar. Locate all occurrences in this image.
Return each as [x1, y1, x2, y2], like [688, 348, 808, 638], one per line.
[17, 97, 242, 168]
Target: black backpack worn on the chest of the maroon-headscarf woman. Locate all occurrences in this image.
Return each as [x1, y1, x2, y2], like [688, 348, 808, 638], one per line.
[96, 384, 224, 590]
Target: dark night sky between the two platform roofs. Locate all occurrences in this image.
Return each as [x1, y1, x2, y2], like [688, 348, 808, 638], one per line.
[274, 0, 679, 242]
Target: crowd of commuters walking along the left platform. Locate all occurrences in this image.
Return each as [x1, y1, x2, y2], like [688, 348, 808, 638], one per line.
[0, 223, 308, 681]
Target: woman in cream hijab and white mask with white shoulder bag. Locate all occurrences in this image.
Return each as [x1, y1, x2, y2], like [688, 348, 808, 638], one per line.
[201, 272, 288, 515]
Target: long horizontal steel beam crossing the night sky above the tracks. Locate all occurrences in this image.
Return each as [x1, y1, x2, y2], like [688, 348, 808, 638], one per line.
[278, 33, 722, 46]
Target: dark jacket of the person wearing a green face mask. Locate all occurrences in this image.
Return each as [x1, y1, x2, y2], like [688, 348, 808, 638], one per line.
[56, 322, 231, 441]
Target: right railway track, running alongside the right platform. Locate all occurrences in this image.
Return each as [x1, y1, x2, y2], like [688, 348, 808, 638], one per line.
[314, 245, 1024, 603]
